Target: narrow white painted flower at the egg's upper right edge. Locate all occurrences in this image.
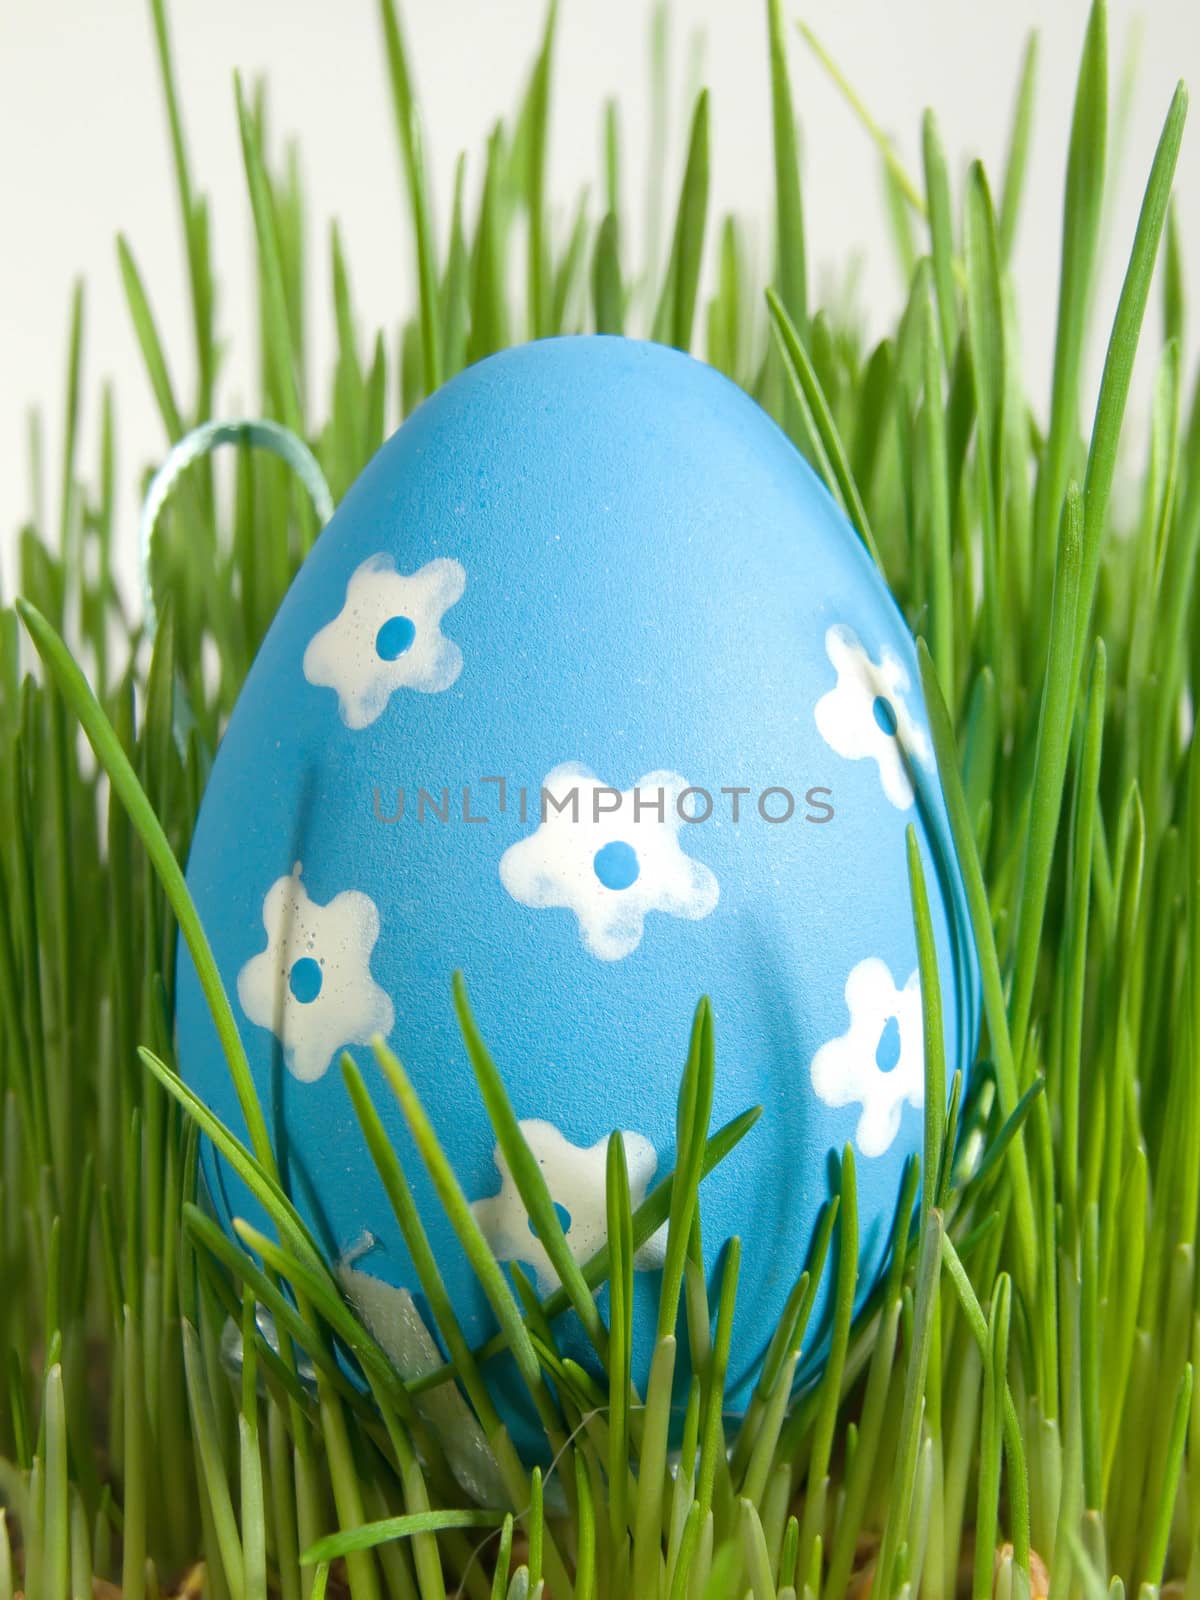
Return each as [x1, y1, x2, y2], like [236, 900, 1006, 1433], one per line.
[813, 622, 933, 811]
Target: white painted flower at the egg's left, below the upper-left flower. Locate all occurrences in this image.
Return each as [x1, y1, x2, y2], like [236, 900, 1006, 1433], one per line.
[237, 861, 395, 1083]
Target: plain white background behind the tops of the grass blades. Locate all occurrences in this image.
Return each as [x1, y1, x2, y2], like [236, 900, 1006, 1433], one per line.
[0, 0, 1200, 601]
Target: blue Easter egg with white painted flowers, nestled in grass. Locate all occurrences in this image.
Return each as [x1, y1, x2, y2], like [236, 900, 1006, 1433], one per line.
[178, 338, 979, 1465]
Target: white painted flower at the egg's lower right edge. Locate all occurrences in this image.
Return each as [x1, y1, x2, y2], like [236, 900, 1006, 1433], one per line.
[810, 955, 925, 1155]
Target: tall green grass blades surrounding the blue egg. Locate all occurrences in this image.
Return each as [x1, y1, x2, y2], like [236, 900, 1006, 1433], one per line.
[0, 0, 1200, 1600]
